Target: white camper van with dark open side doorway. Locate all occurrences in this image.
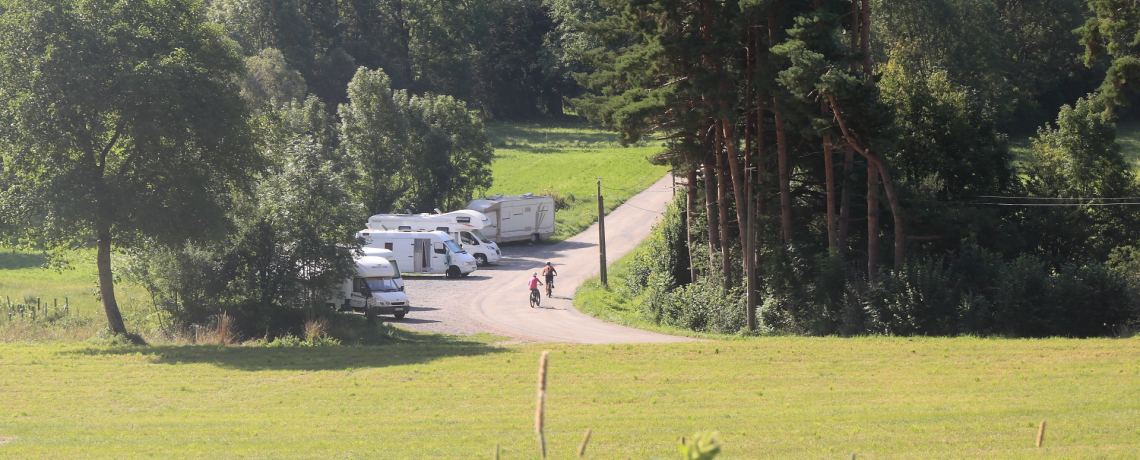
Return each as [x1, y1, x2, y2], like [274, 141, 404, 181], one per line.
[357, 229, 477, 278]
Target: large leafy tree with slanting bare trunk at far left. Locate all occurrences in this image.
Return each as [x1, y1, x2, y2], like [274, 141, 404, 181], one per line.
[0, 0, 262, 332]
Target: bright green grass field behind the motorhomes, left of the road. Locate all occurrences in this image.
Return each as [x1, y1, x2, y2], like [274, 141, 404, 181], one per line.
[487, 121, 668, 240]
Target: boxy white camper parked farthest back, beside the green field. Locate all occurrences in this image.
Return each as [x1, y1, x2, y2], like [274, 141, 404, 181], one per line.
[467, 194, 554, 243]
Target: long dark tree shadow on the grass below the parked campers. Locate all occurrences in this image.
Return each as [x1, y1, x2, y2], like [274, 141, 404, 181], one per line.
[64, 330, 506, 371]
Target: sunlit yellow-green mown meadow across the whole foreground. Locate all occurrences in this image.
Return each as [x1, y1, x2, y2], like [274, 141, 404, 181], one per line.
[0, 336, 1140, 459]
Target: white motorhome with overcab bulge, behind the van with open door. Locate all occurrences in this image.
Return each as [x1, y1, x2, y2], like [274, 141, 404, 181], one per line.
[368, 210, 503, 265]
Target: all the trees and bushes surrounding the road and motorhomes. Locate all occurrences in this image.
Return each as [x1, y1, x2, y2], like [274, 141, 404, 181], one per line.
[0, 0, 1140, 336]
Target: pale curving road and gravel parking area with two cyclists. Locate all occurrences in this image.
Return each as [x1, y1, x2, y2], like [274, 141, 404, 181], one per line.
[394, 175, 691, 344]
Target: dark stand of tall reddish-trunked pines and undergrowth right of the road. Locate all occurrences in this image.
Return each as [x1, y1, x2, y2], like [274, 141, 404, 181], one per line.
[575, 0, 1140, 336]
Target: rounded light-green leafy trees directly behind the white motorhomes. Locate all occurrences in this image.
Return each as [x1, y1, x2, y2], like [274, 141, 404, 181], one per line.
[339, 67, 492, 213]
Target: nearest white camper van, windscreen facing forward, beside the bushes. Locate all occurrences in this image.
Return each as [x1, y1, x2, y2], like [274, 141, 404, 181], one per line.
[328, 255, 412, 318]
